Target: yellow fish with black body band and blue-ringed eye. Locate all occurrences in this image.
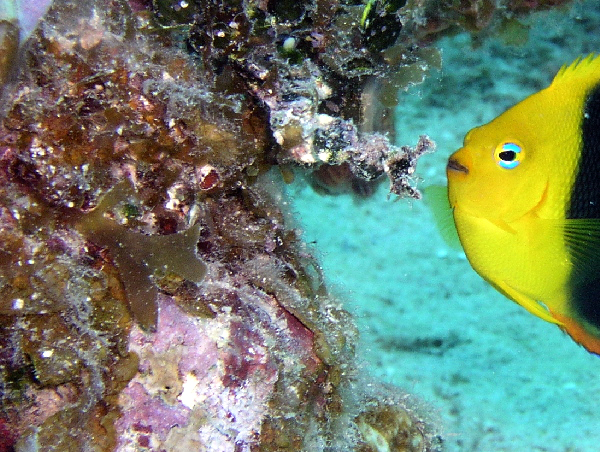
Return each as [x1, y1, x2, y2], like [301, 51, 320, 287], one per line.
[446, 54, 600, 354]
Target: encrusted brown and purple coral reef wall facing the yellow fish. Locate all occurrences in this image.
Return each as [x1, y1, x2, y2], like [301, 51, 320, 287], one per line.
[0, 0, 572, 451]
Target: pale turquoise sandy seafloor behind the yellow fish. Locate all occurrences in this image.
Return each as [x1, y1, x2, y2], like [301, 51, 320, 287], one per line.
[289, 0, 600, 452]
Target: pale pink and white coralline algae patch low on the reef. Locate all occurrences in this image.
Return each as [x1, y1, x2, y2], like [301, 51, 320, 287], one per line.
[116, 295, 286, 451]
